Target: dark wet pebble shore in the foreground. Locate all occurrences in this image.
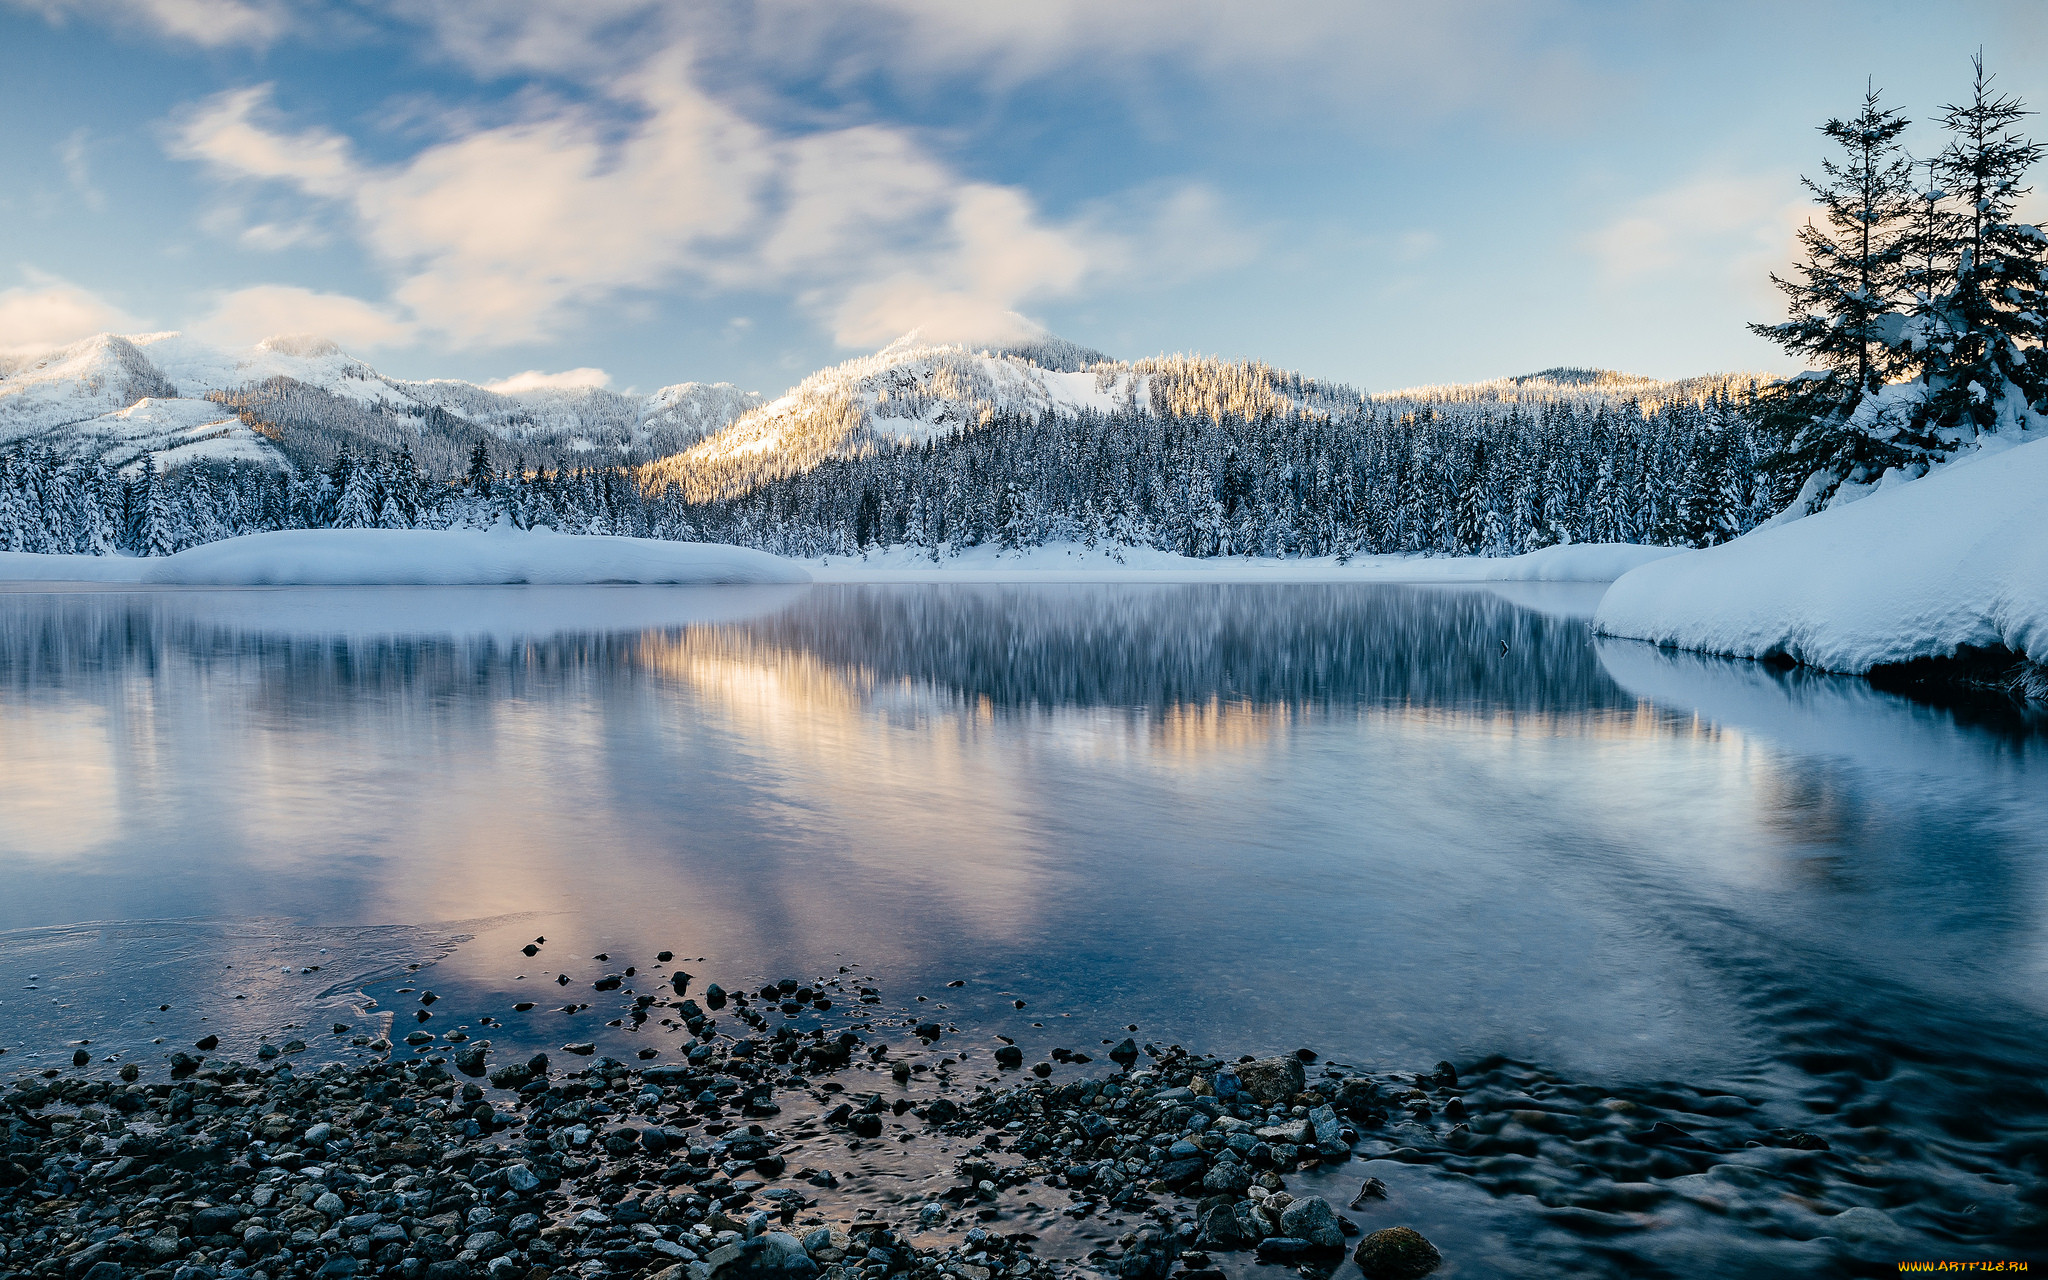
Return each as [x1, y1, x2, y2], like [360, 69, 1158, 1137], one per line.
[0, 956, 1456, 1280]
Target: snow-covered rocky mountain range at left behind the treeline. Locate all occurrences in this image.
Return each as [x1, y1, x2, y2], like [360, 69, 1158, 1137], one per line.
[0, 334, 760, 473]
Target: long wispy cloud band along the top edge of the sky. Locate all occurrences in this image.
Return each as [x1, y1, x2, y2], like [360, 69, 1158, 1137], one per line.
[391, 0, 1605, 137]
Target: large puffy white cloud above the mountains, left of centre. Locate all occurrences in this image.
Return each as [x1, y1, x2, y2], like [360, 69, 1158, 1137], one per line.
[174, 65, 1126, 346]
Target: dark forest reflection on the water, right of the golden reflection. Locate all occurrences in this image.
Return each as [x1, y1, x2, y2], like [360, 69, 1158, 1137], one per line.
[731, 586, 1634, 715]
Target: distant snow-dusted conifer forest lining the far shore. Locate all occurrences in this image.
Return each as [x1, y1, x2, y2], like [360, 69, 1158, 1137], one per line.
[0, 379, 1796, 557]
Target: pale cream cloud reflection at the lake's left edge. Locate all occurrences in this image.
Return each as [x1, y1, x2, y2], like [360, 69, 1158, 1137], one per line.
[0, 696, 117, 860]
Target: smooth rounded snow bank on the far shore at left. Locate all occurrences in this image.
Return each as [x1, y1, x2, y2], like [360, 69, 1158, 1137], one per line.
[0, 528, 811, 586]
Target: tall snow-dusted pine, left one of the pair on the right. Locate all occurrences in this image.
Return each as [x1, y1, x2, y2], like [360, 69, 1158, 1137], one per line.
[1749, 77, 1921, 510]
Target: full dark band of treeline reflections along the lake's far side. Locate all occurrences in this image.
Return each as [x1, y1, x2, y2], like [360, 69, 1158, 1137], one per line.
[0, 586, 1634, 717]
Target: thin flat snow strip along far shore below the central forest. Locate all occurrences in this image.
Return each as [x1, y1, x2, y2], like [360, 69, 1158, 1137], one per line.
[805, 543, 1679, 582]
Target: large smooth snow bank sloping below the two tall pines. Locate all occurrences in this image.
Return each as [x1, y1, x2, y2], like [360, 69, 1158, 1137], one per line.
[1593, 440, 2048, 672]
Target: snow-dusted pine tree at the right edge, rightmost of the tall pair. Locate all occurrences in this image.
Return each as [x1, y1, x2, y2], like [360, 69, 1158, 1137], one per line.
[1923, 53, 2048, 436]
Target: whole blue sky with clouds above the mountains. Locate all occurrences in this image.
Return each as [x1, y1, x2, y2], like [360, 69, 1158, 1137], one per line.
[0, 0, 2048, 395]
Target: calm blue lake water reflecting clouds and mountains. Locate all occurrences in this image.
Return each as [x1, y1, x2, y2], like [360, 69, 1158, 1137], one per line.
[0, 586, 2048, 1276]
